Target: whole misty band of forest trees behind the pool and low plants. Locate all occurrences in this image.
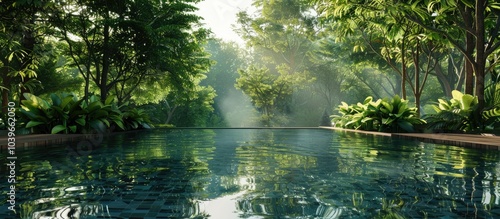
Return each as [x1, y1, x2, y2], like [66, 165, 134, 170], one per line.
[0, 0, 500, 130]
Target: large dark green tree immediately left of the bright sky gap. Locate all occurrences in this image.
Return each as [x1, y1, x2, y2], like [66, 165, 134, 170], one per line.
[53, 0, 210, 102]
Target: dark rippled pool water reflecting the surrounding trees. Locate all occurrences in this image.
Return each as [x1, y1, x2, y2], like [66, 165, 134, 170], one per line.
[0, 129, 500, 219]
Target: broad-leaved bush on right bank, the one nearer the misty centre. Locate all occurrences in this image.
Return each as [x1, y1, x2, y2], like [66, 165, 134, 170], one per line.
[332, 95, 425, 132]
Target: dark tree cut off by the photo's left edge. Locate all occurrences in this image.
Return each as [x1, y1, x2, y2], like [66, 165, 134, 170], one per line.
[0, 0, 49, 113]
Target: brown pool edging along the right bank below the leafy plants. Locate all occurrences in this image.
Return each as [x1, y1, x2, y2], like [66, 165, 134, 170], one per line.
[320, 126, 500, 150]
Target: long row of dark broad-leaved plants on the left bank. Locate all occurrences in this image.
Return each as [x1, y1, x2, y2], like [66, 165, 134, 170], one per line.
[19, 93, 150, 134]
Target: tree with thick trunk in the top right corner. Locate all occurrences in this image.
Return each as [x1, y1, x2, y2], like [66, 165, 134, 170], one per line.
[401, 0, 500, 116]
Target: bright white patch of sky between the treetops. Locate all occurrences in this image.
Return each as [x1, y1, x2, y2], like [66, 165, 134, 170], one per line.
[196, 0, 252, 45]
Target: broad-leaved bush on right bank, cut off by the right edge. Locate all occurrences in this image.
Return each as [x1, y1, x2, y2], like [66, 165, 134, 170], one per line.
[425, 87, 500, 132]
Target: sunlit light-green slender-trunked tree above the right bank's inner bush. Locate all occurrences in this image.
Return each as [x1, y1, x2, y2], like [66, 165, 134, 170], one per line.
[315, 1, 464, 116]
